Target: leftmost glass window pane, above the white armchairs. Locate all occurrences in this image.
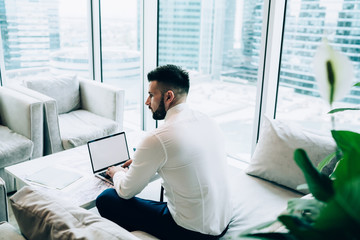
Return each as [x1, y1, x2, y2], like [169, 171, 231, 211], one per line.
[0, 0, 89, 83]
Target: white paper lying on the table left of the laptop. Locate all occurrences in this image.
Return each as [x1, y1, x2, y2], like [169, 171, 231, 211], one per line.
[26, 166, 82, 189]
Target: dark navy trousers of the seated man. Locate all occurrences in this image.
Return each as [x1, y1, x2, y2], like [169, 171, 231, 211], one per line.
[96, 188, 227, 240]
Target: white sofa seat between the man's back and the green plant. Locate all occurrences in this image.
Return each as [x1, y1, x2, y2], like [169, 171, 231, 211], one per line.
[221, 167, 303, 239]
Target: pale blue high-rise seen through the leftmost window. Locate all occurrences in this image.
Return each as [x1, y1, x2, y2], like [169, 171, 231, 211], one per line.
[0, 0, 60, 70]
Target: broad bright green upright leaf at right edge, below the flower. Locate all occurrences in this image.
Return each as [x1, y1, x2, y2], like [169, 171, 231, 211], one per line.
[331, 131, 360, 189]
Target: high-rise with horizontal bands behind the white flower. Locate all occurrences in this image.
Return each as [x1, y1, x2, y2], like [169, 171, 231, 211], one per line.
[280, 0, 360, 103]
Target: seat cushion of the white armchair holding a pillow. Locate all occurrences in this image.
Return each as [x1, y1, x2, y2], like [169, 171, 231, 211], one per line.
[59, 110, 118, 149]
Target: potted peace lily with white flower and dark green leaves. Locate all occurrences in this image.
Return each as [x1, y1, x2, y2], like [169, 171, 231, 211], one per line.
[242, 42, 360, 240]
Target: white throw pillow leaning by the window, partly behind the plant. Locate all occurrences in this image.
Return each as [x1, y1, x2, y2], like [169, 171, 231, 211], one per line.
[246, 117, 336, 193]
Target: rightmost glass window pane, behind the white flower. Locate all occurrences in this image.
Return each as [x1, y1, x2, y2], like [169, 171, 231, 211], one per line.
[276, 0, 360, 132]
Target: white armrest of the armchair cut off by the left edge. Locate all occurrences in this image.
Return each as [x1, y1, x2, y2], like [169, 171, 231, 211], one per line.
[0, 87, 44, 158]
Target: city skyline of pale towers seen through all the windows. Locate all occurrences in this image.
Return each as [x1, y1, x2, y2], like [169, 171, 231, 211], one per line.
[0, 0, 360, 161]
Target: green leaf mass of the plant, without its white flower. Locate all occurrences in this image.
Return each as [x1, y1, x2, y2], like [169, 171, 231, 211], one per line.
[239, 130, 360, 240]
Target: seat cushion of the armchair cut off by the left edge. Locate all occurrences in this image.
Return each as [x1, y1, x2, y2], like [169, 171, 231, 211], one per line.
[0, 125, 34, 168]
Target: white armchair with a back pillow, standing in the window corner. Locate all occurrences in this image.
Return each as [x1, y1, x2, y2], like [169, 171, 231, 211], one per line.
[11, 76, 125, 155]
